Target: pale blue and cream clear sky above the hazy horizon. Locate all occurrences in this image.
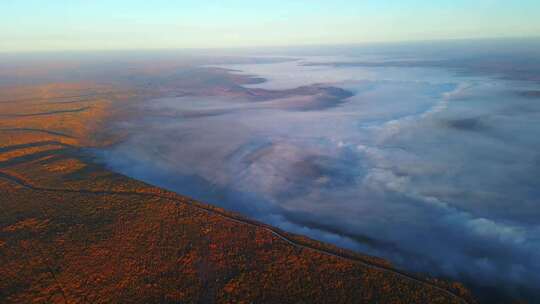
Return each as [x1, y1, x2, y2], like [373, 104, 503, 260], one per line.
[0, 0, 540, 52]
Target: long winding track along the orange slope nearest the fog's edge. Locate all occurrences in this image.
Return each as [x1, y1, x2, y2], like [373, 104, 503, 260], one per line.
[0, 171, 469, 304]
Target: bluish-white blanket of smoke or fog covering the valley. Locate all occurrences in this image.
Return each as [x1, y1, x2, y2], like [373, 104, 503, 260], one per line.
[95, 43, 540, 302]
